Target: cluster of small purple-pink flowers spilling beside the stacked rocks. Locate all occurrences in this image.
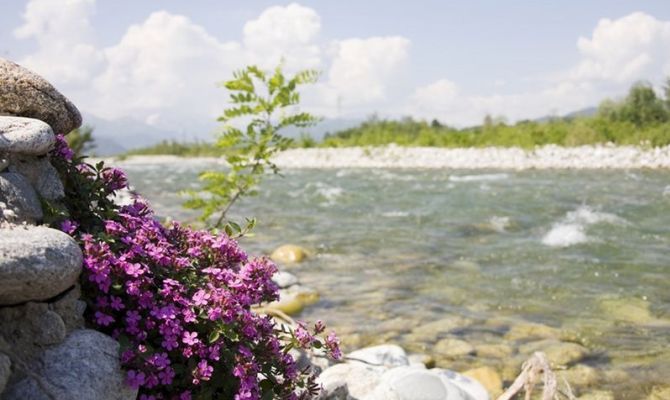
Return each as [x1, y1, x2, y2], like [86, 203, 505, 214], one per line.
[52, 135, 340, 400]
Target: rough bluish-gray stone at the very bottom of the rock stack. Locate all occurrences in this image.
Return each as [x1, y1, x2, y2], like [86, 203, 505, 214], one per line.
[3, 329, 137, 400]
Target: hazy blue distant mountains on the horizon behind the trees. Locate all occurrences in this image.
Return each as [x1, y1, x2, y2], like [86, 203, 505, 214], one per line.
[84, 107, 598, 156]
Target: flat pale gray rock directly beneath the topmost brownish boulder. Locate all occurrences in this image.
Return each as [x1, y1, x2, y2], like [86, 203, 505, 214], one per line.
[0, 117, 56, 155]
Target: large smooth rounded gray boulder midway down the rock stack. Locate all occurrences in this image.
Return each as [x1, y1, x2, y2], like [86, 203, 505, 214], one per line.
[0, 226, 82, 305]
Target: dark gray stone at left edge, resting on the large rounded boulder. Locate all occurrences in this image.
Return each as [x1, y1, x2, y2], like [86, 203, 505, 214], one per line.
[0, 172, 44, 223]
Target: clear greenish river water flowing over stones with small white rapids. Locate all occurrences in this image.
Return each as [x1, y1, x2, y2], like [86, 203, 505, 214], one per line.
[118, 160, 670, 399]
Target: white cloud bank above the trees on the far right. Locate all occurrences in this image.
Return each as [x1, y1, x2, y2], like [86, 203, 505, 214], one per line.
[405, 12, 670, 126]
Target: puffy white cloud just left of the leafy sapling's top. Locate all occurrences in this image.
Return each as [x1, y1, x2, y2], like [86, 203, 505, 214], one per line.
[88, 11, 241, 125]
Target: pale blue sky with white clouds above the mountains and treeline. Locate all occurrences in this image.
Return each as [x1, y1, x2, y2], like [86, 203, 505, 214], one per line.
[0, 0, 670, 134]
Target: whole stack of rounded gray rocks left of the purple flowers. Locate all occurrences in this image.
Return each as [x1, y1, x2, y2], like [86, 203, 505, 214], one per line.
[0, 58, 137, 400]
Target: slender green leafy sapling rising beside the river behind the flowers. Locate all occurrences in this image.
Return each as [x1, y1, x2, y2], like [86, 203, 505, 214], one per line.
[184, 65, 319, 231]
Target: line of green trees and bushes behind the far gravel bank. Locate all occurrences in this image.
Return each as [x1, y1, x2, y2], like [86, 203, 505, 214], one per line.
[123, 78, 670, 157]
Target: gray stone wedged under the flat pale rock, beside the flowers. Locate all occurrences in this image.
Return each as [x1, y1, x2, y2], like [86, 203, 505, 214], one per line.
[8, 154, 65, 200]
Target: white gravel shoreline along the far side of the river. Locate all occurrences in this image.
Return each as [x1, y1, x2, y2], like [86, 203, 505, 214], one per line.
[107, 145, 670, 170]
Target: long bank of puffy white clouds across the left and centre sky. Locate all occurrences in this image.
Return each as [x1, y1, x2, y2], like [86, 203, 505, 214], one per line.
[15, 0, 409, 130]
